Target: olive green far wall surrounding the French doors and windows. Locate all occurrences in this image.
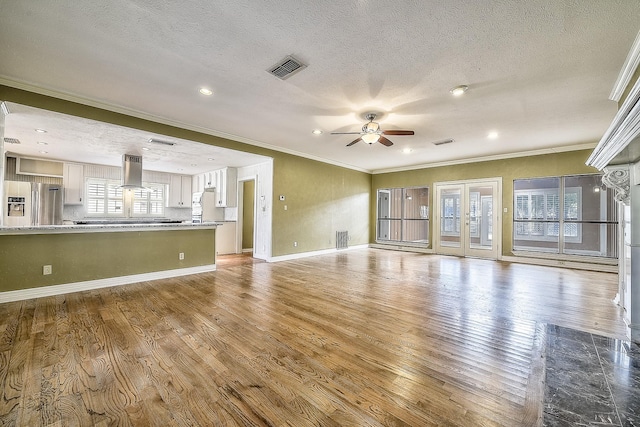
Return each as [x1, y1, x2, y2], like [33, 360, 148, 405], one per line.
[370, 150, 598, 255]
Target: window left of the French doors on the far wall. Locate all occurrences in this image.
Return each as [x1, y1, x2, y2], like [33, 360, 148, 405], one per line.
[376, 187, 429, 244]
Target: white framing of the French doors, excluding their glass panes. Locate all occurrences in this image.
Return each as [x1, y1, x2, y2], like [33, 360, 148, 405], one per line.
[433, 177, 502, 259]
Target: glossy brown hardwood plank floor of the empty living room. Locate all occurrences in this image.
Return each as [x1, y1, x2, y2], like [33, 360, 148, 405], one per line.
[0, 249, 625, 427]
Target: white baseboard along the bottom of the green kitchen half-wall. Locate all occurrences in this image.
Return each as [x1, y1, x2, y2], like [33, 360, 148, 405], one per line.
[0, 264, 216, 303]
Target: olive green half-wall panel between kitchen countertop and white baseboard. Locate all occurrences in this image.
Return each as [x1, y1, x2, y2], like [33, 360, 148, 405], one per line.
[0, 229, 215, 292]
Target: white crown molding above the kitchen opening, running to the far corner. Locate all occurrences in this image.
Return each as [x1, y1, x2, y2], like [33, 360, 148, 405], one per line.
[0, 76, 371, 173]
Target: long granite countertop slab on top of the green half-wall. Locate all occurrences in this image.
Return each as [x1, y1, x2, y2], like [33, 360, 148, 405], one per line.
[0, 222, 223, 235]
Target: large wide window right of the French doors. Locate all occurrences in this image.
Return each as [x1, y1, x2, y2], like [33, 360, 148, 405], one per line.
[513, 174, 617, 258]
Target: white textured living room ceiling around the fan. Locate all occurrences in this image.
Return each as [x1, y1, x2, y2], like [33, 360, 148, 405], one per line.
[0, 0, 640, 176]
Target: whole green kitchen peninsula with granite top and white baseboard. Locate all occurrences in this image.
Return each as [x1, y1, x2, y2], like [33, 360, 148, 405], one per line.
[0, 223, 220, 302]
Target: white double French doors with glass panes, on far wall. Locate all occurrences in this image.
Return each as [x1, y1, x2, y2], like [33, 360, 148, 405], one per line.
[434, 178, 502, 259]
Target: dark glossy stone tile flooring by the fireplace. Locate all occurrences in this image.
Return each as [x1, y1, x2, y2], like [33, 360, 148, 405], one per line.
[544, 325, 640, 427]
